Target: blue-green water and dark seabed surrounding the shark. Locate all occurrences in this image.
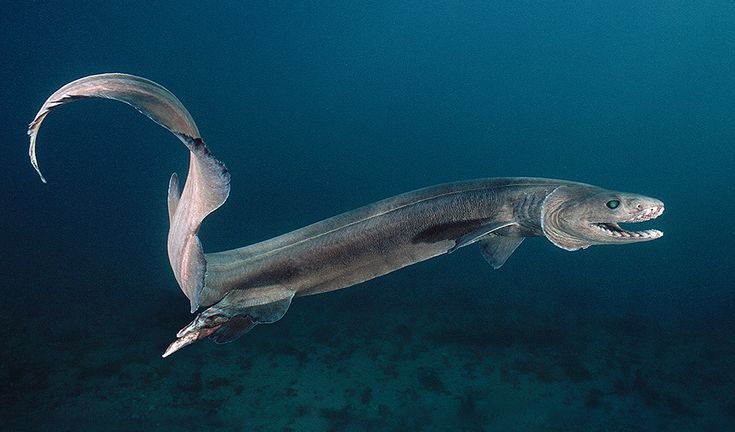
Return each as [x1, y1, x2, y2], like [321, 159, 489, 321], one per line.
[0, 0, 735, 431]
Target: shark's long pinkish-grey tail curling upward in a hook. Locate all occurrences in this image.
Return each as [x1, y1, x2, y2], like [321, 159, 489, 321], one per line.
[28, 73, 230, 312]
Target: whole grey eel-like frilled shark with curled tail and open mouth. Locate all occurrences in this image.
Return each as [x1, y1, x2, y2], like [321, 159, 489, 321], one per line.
[29, 74, 664, 357]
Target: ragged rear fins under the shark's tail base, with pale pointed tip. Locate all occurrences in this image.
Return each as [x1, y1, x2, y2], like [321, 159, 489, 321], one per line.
[163, 286, 295, 357]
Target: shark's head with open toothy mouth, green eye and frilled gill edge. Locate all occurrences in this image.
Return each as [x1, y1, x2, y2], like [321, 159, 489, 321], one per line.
[541, 184, 664, 250]
